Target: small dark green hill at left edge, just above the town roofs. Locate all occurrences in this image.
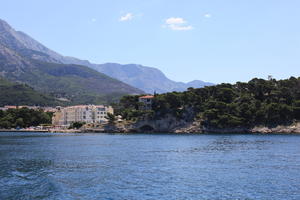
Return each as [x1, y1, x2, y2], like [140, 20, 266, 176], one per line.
[0, 77, 63, 106]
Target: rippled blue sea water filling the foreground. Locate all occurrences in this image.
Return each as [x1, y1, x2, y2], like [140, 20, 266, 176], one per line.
[0, 133, 300, 200]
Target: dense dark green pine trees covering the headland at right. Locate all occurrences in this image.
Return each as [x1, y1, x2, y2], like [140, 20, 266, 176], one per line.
[115, 77, 300, 128]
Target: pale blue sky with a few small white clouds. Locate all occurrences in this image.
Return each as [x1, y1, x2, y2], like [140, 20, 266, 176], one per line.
[0, 0, 300, 83]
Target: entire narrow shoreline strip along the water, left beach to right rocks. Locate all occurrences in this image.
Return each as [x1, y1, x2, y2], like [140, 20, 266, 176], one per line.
[0, 119, 300, 134]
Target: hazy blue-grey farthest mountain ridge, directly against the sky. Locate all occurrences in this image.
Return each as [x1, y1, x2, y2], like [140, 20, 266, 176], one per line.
[0, 20, 214, 93]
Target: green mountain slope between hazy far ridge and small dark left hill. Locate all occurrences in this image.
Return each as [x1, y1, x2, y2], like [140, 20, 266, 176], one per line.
[0, 44, 142, 104]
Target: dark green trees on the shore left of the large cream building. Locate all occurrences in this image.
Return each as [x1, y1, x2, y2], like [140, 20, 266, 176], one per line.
[0, 108, 52, 129]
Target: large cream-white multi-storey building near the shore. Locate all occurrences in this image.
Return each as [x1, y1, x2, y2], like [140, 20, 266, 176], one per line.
[52, 105, 113, 126]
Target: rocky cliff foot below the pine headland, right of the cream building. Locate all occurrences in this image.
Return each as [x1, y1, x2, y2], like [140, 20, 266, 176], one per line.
[84, 117, 300, 134]
